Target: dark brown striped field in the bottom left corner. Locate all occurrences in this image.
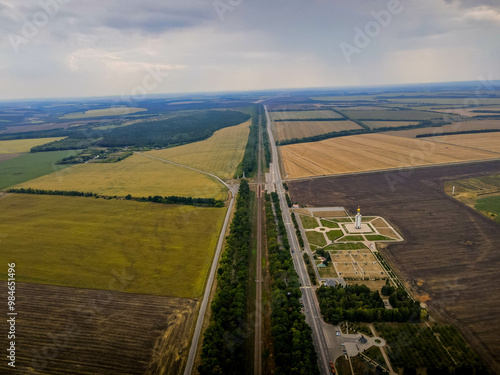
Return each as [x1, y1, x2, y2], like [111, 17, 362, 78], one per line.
[0, 284, 196, 375]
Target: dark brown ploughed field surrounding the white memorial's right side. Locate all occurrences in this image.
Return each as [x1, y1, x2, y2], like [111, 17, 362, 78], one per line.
[288, 161, 500, 373]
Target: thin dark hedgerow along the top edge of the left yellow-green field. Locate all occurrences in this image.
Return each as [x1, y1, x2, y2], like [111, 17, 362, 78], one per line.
[8, 188, 224, 207]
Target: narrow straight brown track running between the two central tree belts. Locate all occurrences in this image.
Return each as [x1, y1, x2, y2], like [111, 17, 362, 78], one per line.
[254, 109, 263, 375]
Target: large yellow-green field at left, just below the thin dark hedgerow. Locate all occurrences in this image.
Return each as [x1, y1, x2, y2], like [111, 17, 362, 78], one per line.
[0, 194, 226, 298]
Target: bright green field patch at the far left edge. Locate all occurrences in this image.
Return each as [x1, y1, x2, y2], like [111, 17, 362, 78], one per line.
[0, 151, 80, 190]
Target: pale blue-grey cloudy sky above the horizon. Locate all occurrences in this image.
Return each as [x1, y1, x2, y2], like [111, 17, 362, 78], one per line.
[0, 0, 500, 99]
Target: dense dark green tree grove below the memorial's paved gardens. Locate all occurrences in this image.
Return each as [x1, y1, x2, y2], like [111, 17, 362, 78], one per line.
[316, 285, 427, 324]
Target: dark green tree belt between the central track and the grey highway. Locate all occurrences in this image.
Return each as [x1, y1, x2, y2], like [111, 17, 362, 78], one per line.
[265, 193, 319, 375]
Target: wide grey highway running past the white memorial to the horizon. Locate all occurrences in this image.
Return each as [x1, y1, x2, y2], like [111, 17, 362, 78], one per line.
[264, 106, 342, 374]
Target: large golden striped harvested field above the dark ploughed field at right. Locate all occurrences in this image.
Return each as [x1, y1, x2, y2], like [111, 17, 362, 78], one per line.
[280, 134, 500, 179]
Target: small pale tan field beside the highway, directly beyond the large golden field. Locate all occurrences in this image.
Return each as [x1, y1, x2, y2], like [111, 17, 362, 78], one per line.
[273, 120, 361, 141]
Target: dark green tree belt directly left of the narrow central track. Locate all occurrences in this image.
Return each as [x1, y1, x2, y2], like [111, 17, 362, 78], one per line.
[198, 180, 252, 375]
